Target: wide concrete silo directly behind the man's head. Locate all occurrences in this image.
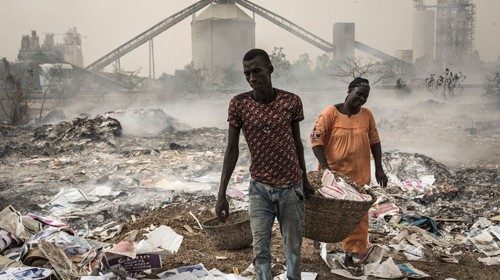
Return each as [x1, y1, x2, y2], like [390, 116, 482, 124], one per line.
[191, 1, 255, 73]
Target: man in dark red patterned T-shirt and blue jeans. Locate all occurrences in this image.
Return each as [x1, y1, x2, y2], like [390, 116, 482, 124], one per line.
[216, 49, 312, 280]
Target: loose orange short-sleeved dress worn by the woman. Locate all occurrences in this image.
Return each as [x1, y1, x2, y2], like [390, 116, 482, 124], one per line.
[310, 106, 380, 253]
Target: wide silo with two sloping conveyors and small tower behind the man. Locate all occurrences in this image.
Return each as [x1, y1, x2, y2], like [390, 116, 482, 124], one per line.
[86, 0, 412, 78]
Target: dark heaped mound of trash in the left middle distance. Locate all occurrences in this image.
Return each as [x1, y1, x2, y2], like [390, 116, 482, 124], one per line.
[33, 116, 122, 143]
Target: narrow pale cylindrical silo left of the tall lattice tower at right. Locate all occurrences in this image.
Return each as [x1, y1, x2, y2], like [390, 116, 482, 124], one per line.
[413, 8, 435, 60]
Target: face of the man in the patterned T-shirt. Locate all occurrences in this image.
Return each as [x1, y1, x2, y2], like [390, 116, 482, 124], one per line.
[243, 56, 272, 91]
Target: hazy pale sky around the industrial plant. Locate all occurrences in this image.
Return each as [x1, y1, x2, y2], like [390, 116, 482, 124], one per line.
[0, 0, 500, 76]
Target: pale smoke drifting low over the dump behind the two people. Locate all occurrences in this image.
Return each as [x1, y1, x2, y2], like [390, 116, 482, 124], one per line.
[42, 80, 500, 168]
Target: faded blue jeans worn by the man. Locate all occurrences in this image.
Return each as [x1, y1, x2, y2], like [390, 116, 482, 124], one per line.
[248, 179, 304, 280]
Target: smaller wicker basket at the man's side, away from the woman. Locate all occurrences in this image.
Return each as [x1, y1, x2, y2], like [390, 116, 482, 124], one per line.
[202, 210, 252, 250]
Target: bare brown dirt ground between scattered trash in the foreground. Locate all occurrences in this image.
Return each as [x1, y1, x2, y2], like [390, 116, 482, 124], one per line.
[116, 199, 500, 280]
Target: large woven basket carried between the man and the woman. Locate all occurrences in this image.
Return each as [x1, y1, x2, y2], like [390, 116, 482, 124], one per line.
[303, 171, 377, 243]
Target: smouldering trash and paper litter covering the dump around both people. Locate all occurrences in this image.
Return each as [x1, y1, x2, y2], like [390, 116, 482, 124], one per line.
[0, 105, 500, 279]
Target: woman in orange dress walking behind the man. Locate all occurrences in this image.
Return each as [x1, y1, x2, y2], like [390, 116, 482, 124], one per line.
[311, 77, 387, 275]
